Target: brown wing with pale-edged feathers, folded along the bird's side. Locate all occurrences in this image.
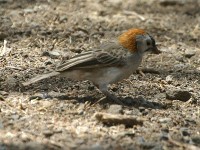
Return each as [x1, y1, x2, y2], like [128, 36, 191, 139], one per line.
[57, 42, 128, 72]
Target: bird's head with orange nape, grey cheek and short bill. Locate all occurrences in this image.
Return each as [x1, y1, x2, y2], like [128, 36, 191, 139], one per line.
[118, 29, 160, 54]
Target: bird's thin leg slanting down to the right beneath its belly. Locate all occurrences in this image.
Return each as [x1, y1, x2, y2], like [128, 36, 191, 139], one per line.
[98, 85, 124, 105]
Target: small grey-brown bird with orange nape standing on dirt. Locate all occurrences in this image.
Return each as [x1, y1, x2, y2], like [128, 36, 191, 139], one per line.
[22, 28, 161, 104]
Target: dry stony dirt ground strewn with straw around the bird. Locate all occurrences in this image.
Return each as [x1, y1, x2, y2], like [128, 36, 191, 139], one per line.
[0, 0, 200, 150]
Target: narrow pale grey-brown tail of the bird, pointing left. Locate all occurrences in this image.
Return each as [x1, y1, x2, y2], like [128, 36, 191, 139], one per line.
[22, 71, 60, 86]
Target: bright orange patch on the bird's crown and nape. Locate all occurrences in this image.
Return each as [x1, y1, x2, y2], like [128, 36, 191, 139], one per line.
[118, 29, 146, 52]
